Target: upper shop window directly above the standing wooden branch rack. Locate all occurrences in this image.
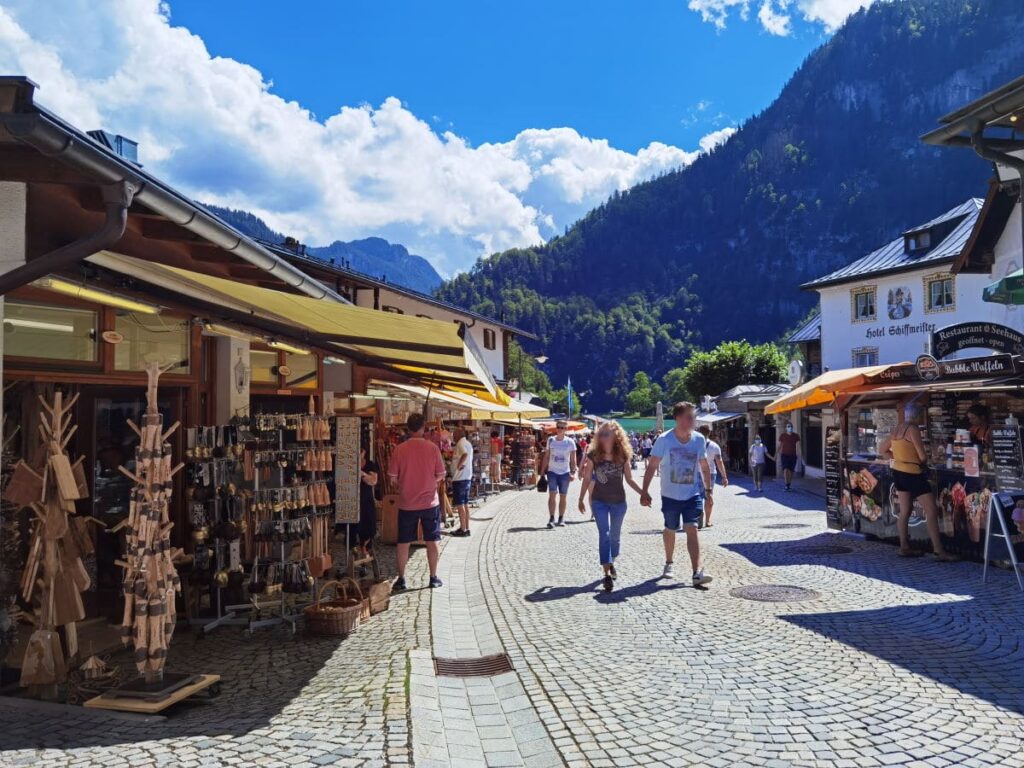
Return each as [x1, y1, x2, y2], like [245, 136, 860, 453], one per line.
[114, 312, 191, 374]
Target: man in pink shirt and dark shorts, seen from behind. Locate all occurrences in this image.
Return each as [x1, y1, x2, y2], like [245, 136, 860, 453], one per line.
[387, 414, 445, 592]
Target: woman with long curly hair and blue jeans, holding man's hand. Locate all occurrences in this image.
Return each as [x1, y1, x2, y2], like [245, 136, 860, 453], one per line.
[580, 421, 641, 592]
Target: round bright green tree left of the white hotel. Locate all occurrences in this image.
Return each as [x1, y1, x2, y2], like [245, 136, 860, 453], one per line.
[673, 341, 786, 402]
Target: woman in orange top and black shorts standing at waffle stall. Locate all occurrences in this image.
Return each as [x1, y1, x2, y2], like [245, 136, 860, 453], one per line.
[881, 398, 958, 562]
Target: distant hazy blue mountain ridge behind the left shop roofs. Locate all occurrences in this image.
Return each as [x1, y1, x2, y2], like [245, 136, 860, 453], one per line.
[206, 205, 441, 293]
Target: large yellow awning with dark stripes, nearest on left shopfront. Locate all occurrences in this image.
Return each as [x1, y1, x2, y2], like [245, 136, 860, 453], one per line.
[89, 252, 500, 396]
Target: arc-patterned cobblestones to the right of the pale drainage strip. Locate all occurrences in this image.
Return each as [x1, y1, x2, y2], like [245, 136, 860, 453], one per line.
[481, 485, 1024, 768]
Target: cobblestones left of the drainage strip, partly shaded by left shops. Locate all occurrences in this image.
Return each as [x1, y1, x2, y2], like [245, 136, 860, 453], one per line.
[0, 548, 430, 768]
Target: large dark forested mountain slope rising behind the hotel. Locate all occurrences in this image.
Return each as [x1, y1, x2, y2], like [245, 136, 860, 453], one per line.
[439, 0, 1024, 407]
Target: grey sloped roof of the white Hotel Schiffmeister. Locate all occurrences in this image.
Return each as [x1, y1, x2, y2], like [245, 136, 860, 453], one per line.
[801, 198, 983, 289]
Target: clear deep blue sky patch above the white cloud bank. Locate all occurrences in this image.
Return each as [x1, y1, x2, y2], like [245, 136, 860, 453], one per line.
[171, 0, 825, 152]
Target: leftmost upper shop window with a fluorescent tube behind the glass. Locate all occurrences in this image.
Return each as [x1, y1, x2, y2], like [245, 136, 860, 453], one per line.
[3, 301, 97, 362]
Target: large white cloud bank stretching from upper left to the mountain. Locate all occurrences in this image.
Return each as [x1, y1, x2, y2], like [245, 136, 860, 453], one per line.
[0, 0, 733, 273]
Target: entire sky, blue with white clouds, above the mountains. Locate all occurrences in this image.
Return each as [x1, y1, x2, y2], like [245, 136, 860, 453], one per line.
[0, 0, 871, 275]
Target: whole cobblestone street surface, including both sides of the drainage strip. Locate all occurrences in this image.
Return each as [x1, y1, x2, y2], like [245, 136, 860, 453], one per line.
[0, 484, 1024, 768]
